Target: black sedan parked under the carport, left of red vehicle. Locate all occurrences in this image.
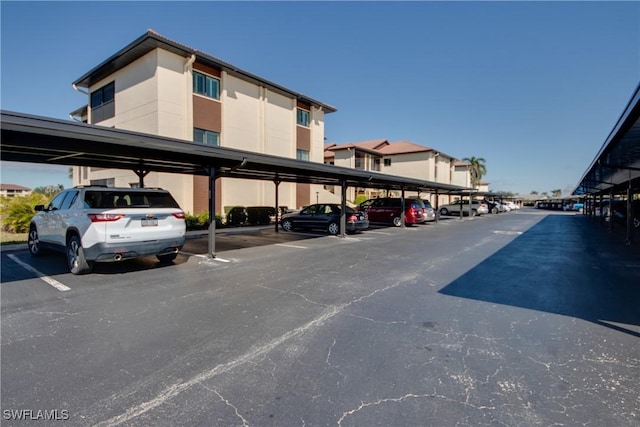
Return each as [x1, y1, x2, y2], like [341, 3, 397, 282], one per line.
[280, 203, 369, 235]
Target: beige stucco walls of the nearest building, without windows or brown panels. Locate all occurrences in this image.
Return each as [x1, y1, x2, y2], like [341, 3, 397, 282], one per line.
[74, 49, 330, 212]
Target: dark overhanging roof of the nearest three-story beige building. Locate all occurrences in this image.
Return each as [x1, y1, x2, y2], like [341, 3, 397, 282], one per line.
[73, 30, 337, 113]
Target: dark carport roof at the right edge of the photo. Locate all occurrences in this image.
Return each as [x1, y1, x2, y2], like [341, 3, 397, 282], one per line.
[573, 85, 640, 195]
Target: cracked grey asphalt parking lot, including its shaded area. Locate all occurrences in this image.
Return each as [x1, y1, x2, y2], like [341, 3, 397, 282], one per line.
[0, 210, 640, 426]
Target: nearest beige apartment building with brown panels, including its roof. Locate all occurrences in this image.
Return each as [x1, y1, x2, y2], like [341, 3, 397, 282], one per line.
[71, 30, 336, 214]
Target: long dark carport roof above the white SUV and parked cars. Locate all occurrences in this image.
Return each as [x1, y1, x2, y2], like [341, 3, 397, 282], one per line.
[0, 110, 470, 193]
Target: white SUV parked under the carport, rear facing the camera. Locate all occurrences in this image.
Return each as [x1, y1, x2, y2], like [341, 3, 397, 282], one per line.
[27, 186, 186, 274]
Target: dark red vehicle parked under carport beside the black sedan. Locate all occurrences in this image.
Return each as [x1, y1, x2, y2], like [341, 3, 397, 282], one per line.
[359, 197, 426, 227]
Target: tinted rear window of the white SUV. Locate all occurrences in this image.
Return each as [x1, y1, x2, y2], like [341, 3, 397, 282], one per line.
[84, 191, 180, 209]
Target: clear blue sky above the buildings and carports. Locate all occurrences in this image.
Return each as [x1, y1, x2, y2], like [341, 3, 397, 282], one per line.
[0, 1, 640, 194]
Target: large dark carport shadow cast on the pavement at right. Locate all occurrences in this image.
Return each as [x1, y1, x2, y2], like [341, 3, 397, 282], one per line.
[440, 215, 640, 337]
